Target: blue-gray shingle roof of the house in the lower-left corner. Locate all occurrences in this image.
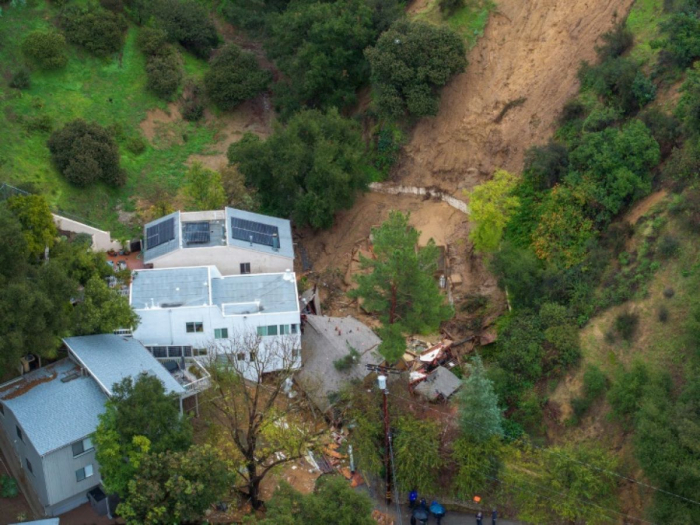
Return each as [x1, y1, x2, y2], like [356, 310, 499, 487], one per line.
[0, 359, 107, 456]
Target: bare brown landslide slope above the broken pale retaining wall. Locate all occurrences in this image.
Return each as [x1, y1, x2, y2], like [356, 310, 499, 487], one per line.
[397, 0, 633, 191]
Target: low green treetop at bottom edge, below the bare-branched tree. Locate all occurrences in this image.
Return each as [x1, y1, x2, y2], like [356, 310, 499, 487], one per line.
[258, 476, 376, 525]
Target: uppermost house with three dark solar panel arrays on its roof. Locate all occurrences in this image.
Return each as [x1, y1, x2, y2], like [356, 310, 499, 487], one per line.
[143, 208, 294, 275]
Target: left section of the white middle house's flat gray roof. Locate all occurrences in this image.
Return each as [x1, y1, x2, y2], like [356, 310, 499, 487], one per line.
[131, 266, 209, 309]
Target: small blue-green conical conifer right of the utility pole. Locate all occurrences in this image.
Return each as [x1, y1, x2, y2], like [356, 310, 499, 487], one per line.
[458, 354, 503, 442]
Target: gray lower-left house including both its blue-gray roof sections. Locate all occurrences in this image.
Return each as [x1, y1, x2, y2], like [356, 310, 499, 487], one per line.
[0, 334, 191, 516]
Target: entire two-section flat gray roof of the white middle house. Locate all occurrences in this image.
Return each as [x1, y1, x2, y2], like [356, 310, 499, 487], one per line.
[131, 266, 299, 315]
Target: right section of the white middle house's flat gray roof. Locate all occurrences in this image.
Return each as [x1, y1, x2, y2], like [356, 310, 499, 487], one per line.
[211, 273, 299, 315]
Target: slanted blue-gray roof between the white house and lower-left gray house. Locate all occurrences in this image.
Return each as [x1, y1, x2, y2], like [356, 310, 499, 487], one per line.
[64, 334, 185, 395]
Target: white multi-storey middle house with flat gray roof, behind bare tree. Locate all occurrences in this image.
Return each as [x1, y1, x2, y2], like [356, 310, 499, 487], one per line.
[129, 266, 301, 379]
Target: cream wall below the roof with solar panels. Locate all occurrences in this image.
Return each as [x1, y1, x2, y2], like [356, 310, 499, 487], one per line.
[151, 246, 294, 275]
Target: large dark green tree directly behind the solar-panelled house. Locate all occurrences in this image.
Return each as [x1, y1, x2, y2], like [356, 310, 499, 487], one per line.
[228, 109, 368, 228]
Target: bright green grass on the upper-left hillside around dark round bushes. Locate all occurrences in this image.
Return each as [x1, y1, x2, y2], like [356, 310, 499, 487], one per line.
[0, 0, 217, 235]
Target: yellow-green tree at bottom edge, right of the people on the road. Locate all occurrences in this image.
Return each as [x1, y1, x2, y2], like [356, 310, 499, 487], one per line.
[503, 444, 617, 524]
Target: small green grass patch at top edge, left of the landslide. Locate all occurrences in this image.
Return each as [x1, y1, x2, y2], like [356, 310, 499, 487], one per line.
[413, 0, 496, 49]
